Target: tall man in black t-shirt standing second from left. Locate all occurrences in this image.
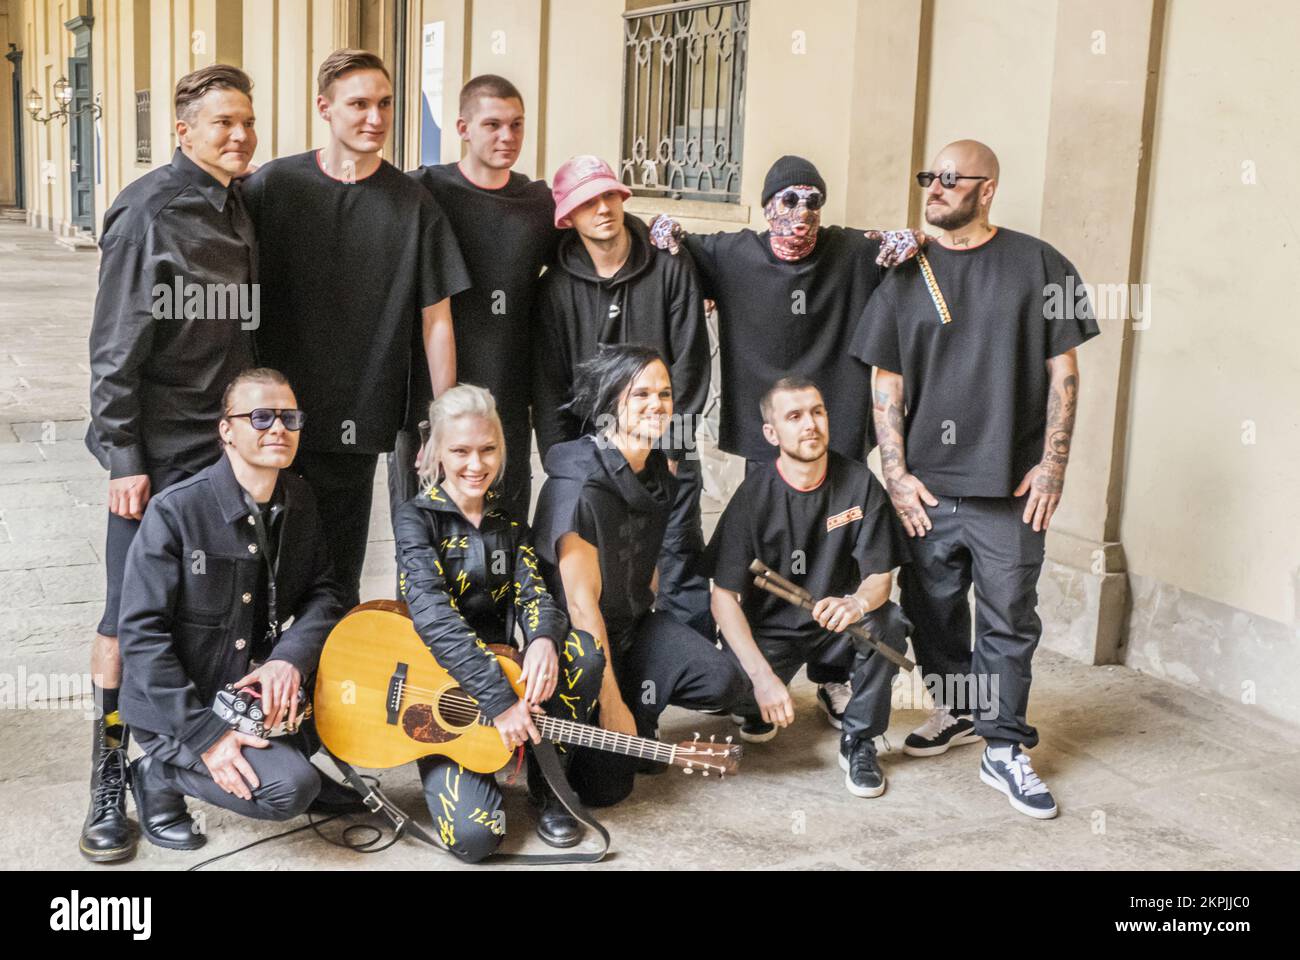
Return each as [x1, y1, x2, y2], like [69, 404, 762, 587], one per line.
[246, 49, 469, 607]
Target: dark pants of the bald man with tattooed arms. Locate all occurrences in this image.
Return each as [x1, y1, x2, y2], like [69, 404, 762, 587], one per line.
[898, 494, 1045, 747]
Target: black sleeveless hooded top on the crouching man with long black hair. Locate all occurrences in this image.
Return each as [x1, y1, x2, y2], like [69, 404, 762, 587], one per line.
[533, 434, 677, 652]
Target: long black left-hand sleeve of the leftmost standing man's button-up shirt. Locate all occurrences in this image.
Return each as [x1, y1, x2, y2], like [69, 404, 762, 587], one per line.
[90, 235, 161, 470]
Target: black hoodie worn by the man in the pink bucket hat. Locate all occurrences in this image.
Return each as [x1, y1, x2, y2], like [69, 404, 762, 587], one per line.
[533, 215, 710, 458]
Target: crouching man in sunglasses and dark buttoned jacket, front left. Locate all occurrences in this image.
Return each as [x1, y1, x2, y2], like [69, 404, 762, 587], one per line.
[118, 369, 358, 849]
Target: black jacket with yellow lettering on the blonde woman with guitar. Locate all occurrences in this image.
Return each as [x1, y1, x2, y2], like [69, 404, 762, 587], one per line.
[393, 484, 568, 717]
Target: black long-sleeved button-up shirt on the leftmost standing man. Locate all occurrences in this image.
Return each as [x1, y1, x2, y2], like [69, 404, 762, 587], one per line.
[86, 150, 260, 477]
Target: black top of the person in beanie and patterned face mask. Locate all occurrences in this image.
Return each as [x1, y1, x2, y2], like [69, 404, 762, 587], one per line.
[686, 226, 881, 460]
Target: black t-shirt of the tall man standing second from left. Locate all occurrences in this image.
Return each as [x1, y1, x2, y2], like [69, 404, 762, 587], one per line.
[244, 151, 469, 453]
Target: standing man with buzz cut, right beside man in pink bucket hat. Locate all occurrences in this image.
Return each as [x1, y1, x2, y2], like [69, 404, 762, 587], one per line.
[405, 74, 560, 519]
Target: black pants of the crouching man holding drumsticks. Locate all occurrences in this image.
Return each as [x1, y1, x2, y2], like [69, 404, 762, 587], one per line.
[732, 630, 906, 740]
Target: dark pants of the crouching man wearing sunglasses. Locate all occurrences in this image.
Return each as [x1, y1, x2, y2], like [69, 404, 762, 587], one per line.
[135, 727, 321, 820]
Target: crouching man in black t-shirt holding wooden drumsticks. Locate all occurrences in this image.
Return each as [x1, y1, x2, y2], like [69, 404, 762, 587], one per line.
[707, 377, 907, 797]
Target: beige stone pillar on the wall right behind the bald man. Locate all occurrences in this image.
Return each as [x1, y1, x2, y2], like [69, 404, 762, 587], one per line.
[1039, 0, 1165, 663]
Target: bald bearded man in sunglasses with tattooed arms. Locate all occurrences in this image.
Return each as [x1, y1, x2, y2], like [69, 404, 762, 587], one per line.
[853, 140, 1099, 820]
